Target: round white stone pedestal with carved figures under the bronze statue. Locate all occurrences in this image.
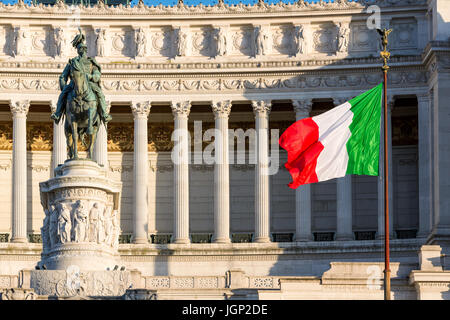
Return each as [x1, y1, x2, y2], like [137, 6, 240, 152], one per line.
[39, 159, 122, 271]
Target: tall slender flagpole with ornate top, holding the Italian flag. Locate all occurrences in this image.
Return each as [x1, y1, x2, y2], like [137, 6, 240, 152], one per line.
[377, 29, 392, 300]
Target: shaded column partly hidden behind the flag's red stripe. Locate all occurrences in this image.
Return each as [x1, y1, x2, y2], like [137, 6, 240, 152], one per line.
[292, 99, 313, 241]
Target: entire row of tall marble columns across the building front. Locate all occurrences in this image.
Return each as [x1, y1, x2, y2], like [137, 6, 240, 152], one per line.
[6, 95, 431, 244]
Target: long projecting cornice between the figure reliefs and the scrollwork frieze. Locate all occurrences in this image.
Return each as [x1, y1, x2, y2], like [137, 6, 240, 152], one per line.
[0, 56, 423, 77]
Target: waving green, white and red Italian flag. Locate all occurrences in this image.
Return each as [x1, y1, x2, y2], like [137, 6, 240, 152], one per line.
[279, 83, 383, 189]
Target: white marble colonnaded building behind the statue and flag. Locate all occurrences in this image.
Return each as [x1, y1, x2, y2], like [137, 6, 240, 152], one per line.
[0, 0, 450, 299]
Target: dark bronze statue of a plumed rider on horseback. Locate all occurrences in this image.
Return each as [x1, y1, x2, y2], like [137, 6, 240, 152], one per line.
[51, 29, 112, 160]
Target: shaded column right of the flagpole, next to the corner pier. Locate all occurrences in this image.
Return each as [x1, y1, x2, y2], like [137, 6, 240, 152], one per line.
[417, 94, 432, 238]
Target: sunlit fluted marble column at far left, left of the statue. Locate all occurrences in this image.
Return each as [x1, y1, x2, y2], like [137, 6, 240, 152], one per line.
[9, 100, 30, 243]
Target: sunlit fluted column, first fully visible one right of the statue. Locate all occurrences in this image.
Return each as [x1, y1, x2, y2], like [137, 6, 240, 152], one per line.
[131, 101, 151, 244]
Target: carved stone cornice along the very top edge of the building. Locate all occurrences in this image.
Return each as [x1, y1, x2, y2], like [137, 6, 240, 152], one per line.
[0, 0, 426, 18]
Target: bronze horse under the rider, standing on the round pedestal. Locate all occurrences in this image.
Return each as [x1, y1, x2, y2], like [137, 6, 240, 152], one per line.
[64, 64, 100, 159]
